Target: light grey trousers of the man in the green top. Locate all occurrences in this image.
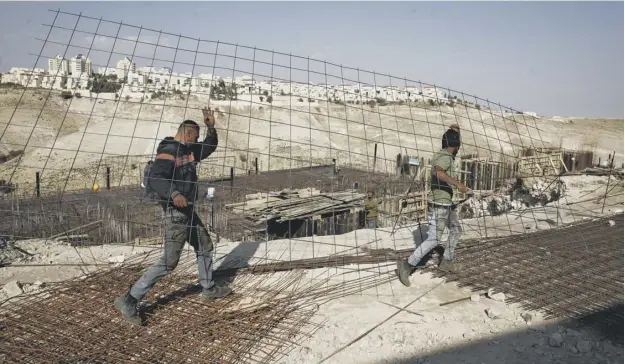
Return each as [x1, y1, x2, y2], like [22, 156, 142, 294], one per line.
[408, 205, 462, 266]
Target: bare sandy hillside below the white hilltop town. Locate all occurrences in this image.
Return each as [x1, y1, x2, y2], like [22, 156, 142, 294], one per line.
[0, 89, 623, 195]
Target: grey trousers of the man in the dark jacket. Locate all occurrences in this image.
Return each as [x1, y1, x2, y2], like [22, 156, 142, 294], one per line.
[130, 207, 215, 300]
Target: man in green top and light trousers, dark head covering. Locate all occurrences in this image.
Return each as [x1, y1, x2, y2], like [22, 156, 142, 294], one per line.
[397, 125, 468, 287]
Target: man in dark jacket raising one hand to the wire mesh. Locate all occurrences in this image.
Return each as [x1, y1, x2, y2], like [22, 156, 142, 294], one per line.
[114, 109, 232, 325]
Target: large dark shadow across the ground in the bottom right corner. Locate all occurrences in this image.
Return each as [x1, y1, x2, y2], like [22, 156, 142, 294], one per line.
[370, 304, 623, 364]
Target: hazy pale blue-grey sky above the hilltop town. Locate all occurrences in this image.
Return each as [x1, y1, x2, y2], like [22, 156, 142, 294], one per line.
[0, 2, 624, 118]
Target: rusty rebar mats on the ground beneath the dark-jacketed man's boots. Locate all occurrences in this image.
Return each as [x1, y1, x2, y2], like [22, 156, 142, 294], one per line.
[0, 255, 388, 363]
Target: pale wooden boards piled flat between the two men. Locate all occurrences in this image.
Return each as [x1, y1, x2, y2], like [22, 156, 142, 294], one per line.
[225, 188, 365, 224]
